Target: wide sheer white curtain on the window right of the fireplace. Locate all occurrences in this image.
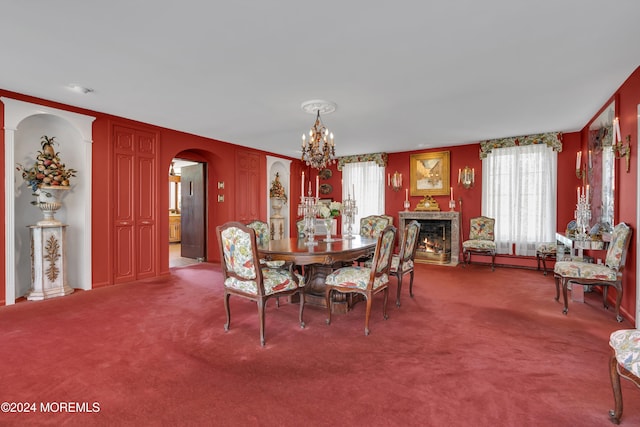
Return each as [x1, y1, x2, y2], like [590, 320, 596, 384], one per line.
[482, 144, 558, 256]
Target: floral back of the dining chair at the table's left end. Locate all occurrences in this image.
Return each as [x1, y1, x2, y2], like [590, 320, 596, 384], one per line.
[216, 222, 264, 295]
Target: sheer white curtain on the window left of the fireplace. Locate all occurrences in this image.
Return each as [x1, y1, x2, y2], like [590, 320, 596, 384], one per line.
[342, 162, 385, 234]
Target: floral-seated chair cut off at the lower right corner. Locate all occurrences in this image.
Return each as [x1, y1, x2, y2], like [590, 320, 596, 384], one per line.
[609, 329, 640, 424]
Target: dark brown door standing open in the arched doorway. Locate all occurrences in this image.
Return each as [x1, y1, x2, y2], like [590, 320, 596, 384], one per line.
[180, 163, 207, 260]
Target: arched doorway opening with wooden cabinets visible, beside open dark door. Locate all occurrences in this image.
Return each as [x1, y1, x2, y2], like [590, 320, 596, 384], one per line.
[169, 158, 204, 268]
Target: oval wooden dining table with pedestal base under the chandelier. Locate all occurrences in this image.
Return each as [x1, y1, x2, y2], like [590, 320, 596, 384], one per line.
[258, 236, 378, 313]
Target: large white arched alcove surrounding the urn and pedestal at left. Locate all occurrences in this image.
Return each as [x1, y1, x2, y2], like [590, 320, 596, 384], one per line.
[0, 98, 95, 305]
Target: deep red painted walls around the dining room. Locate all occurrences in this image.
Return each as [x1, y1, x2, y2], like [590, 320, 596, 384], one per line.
[0, 68, 640, 318]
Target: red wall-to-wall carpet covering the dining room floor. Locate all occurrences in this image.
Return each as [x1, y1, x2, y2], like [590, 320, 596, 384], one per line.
[0, 264, 640, 426]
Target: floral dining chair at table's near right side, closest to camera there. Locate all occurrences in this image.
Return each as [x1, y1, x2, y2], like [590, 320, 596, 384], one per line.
[325, 225, 396, 335]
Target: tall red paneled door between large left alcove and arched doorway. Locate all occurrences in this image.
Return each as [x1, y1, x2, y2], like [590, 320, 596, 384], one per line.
[113, 126, 157, 283]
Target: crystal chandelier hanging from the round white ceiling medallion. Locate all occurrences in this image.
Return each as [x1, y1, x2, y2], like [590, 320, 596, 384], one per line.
[300, 100, 336, 170]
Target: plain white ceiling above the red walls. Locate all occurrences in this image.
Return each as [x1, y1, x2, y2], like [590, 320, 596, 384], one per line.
[0, 0, 640, 157]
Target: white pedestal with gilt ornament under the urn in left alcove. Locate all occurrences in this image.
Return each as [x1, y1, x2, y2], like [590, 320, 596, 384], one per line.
[27, 224, 73, 301]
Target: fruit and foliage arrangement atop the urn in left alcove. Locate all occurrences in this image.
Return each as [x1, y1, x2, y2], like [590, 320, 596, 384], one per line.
[16, 135, 77, 192]
